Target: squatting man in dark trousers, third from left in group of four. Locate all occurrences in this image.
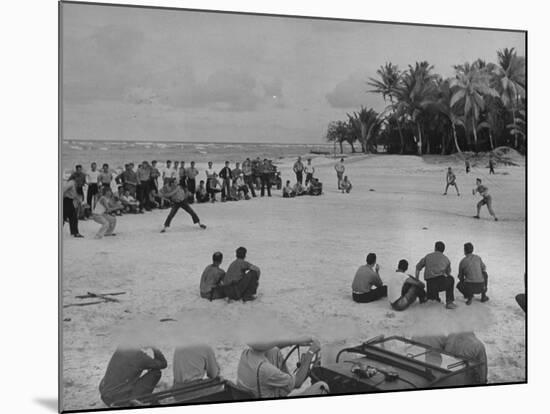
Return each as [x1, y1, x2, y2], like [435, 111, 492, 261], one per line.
[415, 241, 456, 309]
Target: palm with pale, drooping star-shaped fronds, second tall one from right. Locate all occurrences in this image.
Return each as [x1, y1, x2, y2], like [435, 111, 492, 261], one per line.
[450, 63, 498, 151]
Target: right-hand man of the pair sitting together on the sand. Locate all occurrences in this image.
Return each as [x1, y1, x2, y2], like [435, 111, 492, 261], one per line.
[223, 247, 260, 302]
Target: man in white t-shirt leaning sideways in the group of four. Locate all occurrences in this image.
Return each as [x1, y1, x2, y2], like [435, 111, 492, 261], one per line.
[386, 259, 426, 311]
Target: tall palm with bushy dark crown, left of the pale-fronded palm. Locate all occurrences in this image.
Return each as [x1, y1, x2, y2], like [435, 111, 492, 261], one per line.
[395, 62, 436, 155]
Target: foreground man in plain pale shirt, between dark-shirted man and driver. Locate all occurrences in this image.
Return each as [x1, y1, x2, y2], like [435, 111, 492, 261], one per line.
[173, 345, 220, 388]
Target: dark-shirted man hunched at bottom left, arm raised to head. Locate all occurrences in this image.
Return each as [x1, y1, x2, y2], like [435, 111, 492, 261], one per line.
[99, 347, 167, 407]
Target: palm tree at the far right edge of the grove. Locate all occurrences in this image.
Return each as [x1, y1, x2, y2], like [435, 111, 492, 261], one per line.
[497, 48, 525, 148]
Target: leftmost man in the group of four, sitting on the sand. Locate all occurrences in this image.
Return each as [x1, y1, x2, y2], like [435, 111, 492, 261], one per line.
[351, 253, 388, 303]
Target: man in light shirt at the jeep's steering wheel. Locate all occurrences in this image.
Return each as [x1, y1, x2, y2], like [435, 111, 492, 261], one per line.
[237, 338, 329, 398]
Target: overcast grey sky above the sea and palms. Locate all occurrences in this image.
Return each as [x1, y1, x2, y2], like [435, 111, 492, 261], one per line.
[62, 3, 525, 144]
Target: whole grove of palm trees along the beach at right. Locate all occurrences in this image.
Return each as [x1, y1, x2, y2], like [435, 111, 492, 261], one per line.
[326, 48, 527, 155]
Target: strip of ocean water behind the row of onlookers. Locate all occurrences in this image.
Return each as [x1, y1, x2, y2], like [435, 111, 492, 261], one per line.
[61, 140, 333, 173]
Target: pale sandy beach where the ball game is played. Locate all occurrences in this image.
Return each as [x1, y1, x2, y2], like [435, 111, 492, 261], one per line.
[63, 155, 525, 409]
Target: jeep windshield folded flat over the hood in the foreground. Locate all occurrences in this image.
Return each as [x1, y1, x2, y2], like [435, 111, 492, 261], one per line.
[371, 338, 466, 371]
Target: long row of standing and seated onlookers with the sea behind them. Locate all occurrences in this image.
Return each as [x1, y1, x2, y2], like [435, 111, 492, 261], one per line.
[63, 157, 340, 238]
